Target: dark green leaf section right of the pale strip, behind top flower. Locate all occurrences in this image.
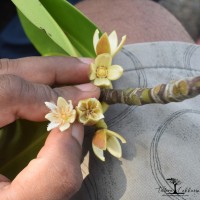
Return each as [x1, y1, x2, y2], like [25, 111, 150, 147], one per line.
[40, 0, 97, 57]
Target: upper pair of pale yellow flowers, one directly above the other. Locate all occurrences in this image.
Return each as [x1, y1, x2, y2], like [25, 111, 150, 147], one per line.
[89, 30, 126, 88]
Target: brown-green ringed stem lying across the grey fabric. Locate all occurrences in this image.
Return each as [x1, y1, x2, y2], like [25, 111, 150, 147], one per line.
[100, 76, 200, 106]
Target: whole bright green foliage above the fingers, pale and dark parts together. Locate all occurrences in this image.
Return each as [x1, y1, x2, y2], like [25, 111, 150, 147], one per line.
[12, 0, 97, 57]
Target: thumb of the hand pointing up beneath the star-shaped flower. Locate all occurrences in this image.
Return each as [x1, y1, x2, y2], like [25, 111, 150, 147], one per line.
[0, 123, 83, 200]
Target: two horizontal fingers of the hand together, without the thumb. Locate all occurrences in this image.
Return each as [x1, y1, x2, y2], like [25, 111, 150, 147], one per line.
[0, 57, 99, 127]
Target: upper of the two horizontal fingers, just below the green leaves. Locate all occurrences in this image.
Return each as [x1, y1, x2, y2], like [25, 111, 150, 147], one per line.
[0, 57, 92, 85]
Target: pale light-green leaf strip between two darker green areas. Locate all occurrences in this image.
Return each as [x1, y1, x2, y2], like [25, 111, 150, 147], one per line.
[12, 0, 79, 56]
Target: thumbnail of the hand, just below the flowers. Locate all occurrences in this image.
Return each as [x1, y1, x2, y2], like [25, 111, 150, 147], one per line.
[72, 123, 84, 146]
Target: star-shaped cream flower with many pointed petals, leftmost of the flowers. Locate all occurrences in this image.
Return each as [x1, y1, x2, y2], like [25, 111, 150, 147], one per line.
[45, 97, 76, 131]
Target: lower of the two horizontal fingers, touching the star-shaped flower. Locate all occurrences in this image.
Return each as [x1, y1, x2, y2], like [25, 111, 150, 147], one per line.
[0, 75, 100, 127]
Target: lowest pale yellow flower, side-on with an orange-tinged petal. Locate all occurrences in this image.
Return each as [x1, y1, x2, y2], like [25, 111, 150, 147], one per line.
[92, 129, 126, 161]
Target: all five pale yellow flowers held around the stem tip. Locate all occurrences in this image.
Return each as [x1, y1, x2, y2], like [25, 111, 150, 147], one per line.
[45, 30, 126, 161]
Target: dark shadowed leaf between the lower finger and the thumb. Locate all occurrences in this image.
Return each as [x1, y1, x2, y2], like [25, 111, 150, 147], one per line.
[0, 120, 48, 179]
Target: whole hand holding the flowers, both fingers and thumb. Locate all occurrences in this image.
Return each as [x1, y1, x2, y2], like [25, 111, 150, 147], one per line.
[0, 57, 100, 200]
